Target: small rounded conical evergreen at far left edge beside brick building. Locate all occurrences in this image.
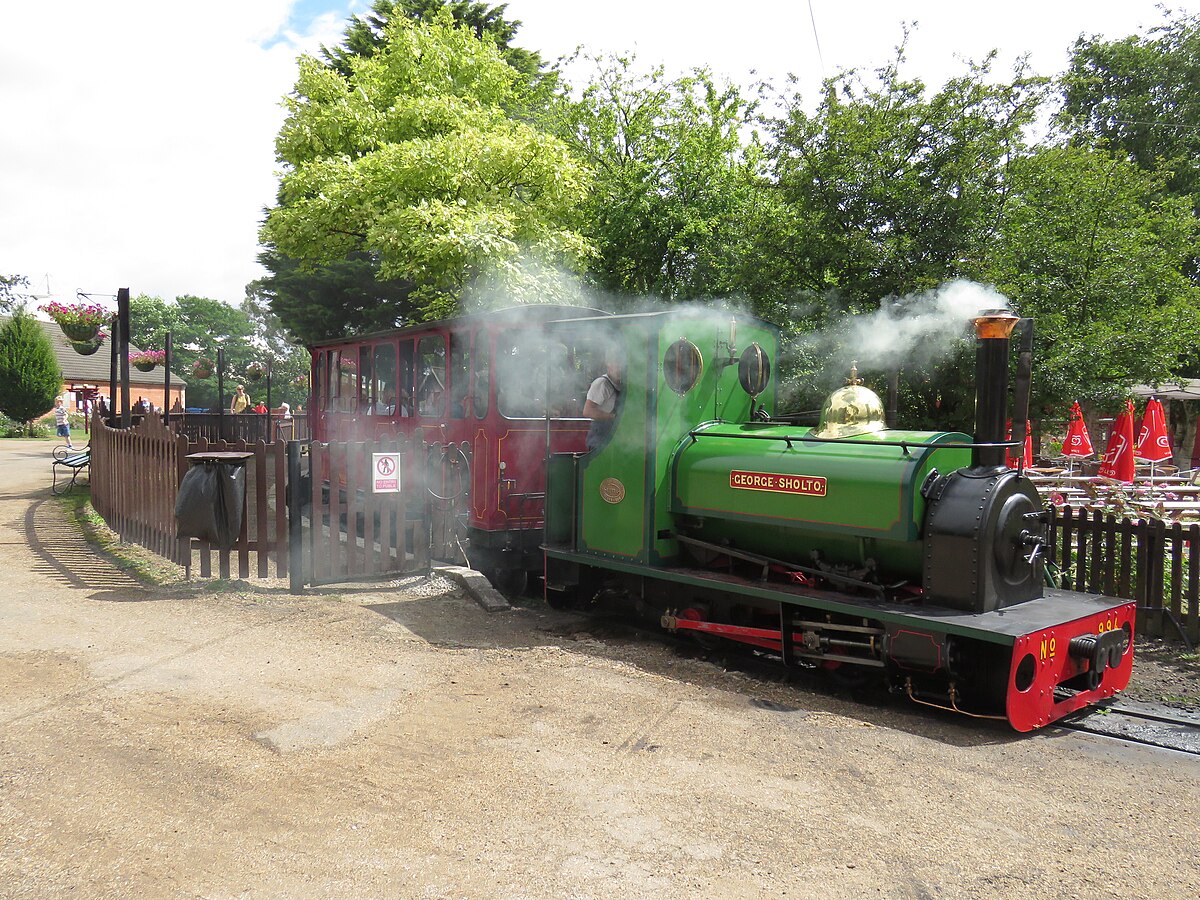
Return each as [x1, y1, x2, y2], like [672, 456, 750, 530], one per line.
[0, 310, 62, 437]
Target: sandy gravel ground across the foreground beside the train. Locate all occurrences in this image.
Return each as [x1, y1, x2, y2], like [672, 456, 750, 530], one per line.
[0, 442, 1200, 898]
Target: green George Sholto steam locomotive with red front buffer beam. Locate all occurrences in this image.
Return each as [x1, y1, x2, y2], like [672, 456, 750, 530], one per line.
[545, 311, 1134, 731]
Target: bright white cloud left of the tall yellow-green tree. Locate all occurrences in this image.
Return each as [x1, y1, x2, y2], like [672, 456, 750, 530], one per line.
[0, 0, 357, 302]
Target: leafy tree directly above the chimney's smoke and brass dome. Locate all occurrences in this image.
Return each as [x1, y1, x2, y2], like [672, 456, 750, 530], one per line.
[773, 47, 1044, 310]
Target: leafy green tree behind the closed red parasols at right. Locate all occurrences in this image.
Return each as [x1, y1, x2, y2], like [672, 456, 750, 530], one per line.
[988, 146, 1200, 409]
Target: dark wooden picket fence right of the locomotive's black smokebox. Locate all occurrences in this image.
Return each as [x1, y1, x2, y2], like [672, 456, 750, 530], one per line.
[1048, 506, 1200, 643]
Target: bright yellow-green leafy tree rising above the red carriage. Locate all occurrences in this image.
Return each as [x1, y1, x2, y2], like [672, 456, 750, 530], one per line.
[262, 13, 589, 317]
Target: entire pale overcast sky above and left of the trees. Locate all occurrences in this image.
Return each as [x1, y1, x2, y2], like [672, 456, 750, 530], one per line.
[0, 0, 1185, 314]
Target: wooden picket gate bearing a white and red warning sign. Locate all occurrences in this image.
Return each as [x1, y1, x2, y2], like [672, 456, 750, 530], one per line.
[288, 437, 430, 590]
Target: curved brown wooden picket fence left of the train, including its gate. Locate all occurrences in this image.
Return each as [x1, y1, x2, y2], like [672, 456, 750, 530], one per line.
[91, 416, 430, 588]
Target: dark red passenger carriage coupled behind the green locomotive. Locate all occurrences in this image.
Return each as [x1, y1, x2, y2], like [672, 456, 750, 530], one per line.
[308, 306, 604, 584]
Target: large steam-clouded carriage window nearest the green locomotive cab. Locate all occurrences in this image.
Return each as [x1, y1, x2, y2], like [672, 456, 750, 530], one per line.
[496, 331, 604, 419]
